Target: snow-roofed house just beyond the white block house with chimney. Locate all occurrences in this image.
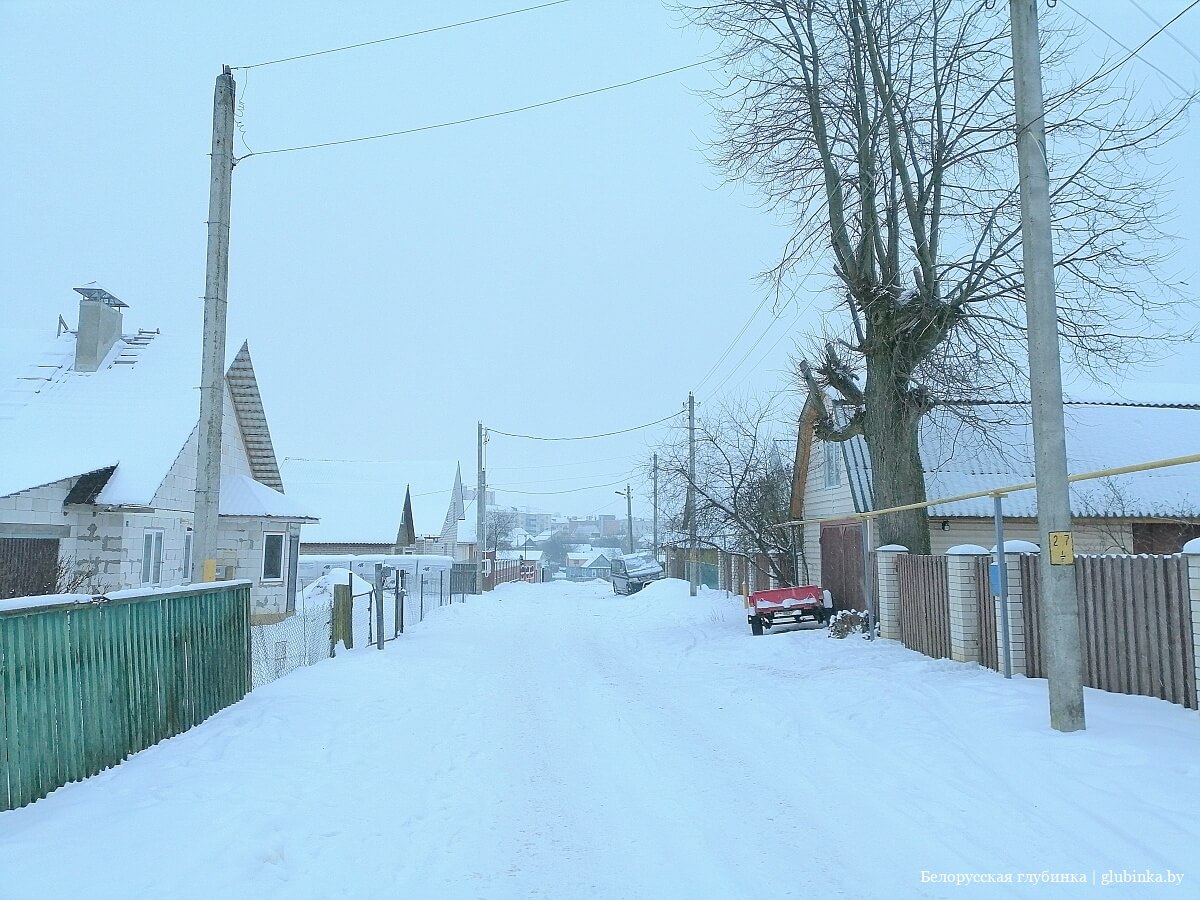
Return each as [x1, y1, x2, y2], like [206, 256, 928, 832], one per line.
[283, 458, 464, 557]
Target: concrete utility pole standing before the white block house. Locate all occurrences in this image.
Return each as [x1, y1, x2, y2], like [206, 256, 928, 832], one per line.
[190, 66, 236, 581]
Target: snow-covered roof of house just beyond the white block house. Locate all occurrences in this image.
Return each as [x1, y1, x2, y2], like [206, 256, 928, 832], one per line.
[282, 458, 461, 544]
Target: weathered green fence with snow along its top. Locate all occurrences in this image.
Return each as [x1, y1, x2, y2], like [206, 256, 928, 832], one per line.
[0, 583, 250, 810]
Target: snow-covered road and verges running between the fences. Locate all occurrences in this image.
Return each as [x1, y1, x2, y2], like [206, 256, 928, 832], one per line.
[0, 582, 1200, 899]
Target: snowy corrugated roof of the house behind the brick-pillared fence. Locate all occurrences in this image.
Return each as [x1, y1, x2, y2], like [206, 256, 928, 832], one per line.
[835, 402, 1200, 518]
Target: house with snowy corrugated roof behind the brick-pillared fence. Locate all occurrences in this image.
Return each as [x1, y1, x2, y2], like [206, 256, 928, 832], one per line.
[791, 397, 1200, 609]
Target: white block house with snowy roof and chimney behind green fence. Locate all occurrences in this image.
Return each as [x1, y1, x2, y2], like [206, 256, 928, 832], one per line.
[0, 288, 317, 613]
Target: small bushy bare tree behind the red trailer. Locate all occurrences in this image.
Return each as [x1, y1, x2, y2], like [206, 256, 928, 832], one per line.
[658, 393, 808, 584]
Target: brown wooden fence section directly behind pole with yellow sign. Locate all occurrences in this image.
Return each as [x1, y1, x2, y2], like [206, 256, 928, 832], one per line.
[1021, 554, 1196, 709]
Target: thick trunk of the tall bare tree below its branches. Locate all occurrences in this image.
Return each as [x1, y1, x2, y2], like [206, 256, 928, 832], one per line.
[863, 359, 929, 553]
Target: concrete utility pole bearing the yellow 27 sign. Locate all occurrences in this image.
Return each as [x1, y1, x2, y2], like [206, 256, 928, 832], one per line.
[1008, 0, 1085, 731]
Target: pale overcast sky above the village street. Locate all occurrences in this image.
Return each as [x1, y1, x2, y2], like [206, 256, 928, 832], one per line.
[0, 0, 1200, 515]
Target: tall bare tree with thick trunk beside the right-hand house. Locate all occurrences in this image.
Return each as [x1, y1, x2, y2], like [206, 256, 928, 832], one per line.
[685, 0, 1190, 552]
